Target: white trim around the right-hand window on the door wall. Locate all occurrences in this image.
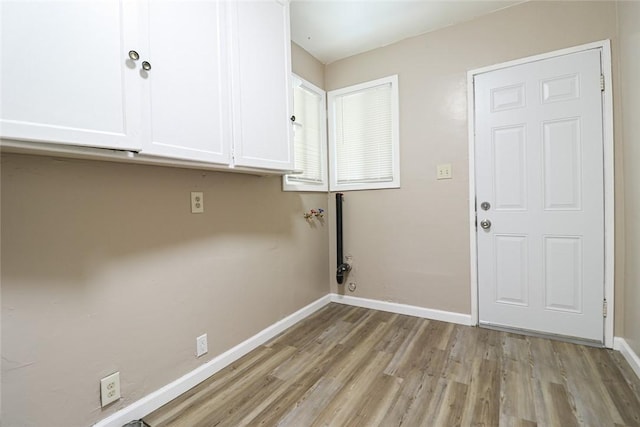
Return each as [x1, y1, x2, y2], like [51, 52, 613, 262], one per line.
[327, 74, 400, 191]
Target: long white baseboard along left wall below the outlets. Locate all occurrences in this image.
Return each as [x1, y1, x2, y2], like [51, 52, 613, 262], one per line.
[94, 295, 331, 427]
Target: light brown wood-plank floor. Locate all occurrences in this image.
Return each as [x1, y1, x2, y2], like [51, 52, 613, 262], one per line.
[144, 304, 640, 427]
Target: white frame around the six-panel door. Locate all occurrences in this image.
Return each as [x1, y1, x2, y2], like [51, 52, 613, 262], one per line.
[467, 39, 615, 348]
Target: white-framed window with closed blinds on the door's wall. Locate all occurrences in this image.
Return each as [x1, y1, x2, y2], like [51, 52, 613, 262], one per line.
[328, 75, 400, 191]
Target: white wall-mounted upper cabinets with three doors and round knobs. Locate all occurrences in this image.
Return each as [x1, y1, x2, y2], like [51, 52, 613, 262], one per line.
[0, 0, 293, 172]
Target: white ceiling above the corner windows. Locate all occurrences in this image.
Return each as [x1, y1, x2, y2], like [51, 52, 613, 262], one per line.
[291, 0, 525, 64]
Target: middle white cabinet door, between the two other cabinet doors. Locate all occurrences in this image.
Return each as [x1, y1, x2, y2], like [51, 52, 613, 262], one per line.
[141, 0, 231, 164]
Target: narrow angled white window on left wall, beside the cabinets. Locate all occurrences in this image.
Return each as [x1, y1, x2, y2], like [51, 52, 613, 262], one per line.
[283, 75, 328, 191]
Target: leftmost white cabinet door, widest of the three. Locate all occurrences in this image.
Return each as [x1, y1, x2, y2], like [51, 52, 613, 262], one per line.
[0, 0, 141, 150]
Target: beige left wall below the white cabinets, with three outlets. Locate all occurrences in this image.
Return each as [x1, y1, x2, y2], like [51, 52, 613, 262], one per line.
[0, 46, 329, 427]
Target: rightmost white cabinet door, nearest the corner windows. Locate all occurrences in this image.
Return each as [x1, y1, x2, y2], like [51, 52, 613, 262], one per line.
[230, 0, 293, 170]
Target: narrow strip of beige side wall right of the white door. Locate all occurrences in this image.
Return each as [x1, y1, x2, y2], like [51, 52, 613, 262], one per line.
[618, 1, 640, 355]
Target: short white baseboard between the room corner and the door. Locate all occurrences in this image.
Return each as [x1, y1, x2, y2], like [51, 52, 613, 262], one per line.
[330, 294, 473, 326]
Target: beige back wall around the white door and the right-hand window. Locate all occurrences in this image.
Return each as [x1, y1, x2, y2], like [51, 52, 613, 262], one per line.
[325, 2, 624, 329]
